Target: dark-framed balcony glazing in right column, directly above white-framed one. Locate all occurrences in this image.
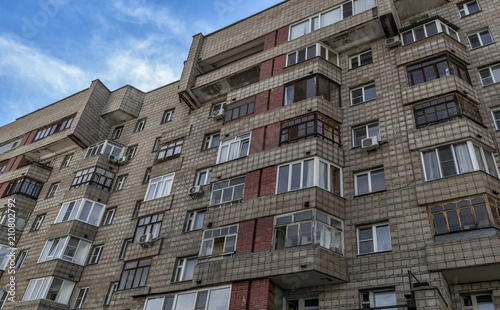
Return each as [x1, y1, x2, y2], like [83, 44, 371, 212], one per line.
[413, 93, 483, 128]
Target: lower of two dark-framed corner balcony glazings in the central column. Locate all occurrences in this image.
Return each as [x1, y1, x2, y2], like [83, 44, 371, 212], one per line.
[280, 112, 340, 145]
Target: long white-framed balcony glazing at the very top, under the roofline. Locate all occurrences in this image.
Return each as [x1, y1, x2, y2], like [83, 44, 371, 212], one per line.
[289, 0, 377, 40]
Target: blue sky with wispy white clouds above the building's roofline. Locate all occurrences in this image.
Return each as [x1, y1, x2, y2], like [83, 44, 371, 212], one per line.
[0, 0, 281, 126]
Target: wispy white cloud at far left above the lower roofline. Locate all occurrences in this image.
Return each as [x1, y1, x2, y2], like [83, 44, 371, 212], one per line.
[0, 35, 90, 96]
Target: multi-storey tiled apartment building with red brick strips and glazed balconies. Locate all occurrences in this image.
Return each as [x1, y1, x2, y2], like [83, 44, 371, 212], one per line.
[0, 0, 500, 310]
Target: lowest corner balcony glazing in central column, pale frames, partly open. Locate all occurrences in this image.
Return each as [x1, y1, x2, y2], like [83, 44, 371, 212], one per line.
[273, 210, 344, 255]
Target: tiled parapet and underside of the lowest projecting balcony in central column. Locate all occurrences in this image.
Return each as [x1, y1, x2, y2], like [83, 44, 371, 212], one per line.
[193, 245, 348, 289]
